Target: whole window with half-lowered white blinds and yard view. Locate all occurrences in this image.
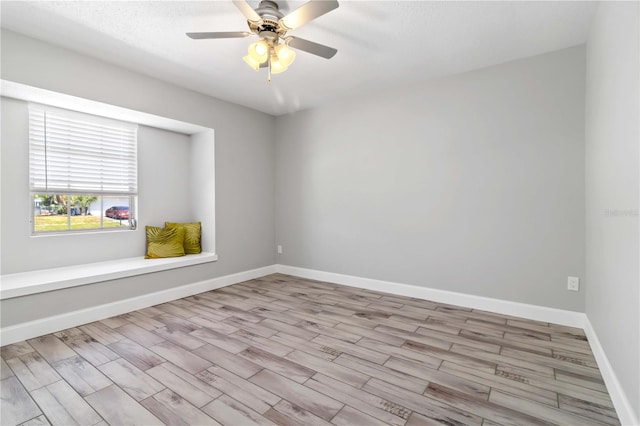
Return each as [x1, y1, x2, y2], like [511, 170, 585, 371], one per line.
[29, 105, 138, 234]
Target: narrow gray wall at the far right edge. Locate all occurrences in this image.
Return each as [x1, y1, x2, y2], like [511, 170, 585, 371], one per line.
[586, 2, 640, 419]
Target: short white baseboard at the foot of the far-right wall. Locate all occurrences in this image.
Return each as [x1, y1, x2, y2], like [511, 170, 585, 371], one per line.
[584, 316, 640, 426]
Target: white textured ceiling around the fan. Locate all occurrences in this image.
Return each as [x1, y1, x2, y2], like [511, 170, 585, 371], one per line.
[1, 0, 597, 115]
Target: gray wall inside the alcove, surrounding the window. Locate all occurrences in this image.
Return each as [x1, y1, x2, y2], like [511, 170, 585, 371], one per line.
[0, 98, 195, 274]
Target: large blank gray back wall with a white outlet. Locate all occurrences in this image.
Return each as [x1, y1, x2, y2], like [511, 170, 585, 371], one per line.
[276, 46, 585, 311]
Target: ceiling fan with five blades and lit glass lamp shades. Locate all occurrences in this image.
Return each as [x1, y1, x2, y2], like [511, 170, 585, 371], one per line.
[187, 0, 338, 81]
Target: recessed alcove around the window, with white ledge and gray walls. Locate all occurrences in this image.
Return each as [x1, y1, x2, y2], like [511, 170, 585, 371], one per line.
[0, 80, 217, 299]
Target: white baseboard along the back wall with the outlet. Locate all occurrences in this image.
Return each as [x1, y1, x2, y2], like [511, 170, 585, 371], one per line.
[276, 265, 585, 328]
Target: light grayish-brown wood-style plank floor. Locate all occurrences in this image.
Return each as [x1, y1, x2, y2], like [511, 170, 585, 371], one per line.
[0, 275, 619, 426]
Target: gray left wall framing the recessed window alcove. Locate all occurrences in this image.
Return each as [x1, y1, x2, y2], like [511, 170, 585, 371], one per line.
[0, 31, 275, 327]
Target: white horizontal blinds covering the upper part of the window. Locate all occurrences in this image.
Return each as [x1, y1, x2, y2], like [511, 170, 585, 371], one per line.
[29, 105, 138, 195]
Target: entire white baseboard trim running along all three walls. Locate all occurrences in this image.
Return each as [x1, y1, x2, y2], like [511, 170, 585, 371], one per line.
[0, 264, 639, 425]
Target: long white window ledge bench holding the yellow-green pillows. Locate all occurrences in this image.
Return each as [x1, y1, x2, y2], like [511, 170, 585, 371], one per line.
[0, 253, 218, 300]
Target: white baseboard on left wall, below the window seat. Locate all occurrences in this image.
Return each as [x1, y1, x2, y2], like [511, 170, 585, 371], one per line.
[0, 265, 276, 346]
